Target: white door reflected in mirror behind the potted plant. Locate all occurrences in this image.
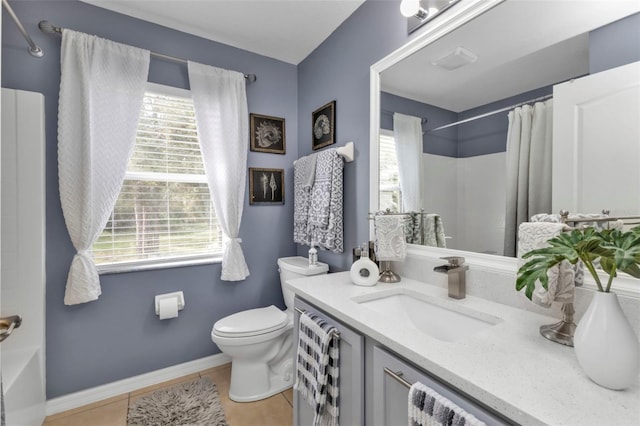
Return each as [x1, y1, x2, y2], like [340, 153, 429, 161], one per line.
[553, 62, 640, 216]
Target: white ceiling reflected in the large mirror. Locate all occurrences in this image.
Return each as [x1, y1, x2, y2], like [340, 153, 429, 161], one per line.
[381, 0, 640, 112]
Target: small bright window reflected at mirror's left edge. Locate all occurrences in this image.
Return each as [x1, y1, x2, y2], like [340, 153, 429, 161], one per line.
[378, 129, 402, 212]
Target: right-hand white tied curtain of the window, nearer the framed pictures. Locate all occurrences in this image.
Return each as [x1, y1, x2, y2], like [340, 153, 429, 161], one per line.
[189, 62, 249, 281]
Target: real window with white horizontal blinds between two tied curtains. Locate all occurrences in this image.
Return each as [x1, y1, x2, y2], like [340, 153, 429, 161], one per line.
[93, 85, 222, 272]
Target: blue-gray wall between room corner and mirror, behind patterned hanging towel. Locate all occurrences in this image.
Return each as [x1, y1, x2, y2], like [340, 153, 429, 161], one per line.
[298, 0, 410, 270]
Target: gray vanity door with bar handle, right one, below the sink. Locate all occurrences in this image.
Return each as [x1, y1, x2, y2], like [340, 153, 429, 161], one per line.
[370, 347, 511, 426]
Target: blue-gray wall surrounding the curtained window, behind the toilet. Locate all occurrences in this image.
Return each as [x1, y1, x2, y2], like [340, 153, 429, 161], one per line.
[2, 0, 298, 399]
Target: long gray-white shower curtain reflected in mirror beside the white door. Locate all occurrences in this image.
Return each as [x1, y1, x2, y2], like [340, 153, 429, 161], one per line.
[504, 100, 553, 256]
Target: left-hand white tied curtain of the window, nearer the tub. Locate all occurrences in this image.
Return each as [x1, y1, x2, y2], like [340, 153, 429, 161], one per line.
[58, 29, 149, 305]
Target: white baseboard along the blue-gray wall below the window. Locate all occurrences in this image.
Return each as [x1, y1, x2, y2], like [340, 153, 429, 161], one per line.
[46, 353, 231, 416]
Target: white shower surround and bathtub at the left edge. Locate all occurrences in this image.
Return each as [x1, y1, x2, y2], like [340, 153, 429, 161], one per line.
[0, 89, 45, 426]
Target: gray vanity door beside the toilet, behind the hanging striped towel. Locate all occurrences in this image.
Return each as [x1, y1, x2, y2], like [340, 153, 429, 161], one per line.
[293, 297, 364, 426]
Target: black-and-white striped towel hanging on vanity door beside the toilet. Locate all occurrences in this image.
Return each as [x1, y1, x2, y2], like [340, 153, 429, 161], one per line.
[293, 312, 340, 426]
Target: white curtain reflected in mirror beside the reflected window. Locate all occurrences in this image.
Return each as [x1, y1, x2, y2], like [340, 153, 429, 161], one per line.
[393, 112, 424, 212]
